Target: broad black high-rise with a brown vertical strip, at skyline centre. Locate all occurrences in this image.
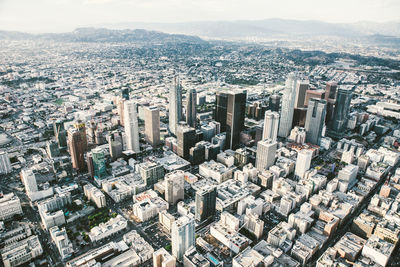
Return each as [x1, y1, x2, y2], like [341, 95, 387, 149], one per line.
[215, 90, 247, 149]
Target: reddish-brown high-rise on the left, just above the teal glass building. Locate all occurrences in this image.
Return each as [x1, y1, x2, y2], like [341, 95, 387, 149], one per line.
[68, 128, 86, 171]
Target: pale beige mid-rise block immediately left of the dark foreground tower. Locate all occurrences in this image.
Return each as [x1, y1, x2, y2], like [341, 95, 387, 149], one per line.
[164, 170, 185, 205]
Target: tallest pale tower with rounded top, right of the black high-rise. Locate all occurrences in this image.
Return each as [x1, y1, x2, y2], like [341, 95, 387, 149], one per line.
[278, 73, 297, 137]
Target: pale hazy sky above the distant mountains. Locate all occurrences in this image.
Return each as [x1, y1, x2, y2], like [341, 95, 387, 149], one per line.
[0, 0, 400, 32]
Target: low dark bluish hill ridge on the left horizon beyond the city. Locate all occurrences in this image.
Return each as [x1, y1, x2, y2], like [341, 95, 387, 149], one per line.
[0, 28, 206, 44]
